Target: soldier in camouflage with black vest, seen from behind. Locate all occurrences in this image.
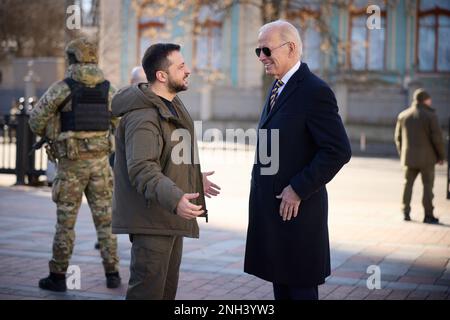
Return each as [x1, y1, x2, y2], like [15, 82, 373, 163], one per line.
[30, 38, 121, 291]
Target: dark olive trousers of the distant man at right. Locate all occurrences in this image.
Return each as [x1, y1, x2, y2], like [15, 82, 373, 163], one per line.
[403, 166, 434, 217]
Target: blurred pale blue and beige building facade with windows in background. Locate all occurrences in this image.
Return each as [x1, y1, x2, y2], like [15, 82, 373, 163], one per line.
[0, 0, 442, 142]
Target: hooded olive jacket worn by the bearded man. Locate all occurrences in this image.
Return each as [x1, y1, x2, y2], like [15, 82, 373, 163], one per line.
[112, 84, 206, 238]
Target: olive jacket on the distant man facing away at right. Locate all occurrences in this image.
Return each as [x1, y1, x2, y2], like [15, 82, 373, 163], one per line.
[395, 102, 445, 168]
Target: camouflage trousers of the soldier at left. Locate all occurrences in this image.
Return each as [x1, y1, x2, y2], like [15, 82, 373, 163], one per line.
[49, 156, 119, 273]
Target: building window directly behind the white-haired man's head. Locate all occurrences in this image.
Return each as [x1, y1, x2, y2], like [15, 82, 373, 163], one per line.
[287, 1, 322, 70]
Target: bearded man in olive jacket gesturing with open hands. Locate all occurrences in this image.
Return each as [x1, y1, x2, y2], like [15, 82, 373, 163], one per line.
[112, 44, 220, 299]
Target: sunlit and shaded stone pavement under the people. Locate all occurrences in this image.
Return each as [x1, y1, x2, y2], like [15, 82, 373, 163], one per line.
[0, 149, 450, 300]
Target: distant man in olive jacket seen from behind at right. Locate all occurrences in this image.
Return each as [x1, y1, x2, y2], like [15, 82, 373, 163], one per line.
[395, 89, 445, 223]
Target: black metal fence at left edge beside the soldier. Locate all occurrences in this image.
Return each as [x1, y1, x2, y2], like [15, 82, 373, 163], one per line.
[0, 98, 47, 185]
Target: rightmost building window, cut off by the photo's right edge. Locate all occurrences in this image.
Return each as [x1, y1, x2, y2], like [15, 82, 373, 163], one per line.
[416, 0, 450, 72]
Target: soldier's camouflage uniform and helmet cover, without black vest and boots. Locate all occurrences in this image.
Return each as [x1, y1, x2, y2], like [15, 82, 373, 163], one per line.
[29, 39, 119, 273]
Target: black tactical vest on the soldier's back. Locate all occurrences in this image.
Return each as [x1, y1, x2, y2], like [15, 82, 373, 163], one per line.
[61, 78, 111, 132]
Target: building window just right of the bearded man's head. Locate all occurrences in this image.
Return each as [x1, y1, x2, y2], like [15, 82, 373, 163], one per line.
[193, 5, 223, 71]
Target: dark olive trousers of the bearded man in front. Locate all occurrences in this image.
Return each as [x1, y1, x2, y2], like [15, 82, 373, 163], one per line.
[126, 234, 183, 300]
